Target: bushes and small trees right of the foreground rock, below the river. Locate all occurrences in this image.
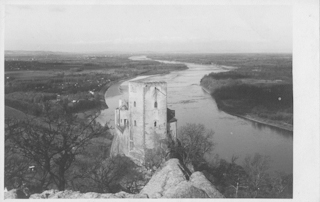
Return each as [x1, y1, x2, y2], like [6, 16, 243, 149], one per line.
[165, 124, 293, 198]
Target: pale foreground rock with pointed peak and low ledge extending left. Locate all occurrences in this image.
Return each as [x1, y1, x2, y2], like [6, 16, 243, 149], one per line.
[5, 159, 224, 199]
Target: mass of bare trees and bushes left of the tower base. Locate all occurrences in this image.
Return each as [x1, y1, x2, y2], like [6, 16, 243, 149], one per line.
[4, 102, 142, 194]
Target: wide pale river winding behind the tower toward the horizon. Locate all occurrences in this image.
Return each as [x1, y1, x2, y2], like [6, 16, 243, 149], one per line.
[98, 56, 293, 174]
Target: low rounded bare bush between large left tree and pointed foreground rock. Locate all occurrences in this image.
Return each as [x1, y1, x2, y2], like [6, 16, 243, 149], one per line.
[72, 155, 143, 193]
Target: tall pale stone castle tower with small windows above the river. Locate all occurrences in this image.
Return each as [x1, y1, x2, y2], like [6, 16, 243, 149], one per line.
[111, 79, 177, 163]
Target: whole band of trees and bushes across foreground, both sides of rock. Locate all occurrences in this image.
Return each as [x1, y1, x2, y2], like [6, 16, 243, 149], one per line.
[5, 106, 292, 198]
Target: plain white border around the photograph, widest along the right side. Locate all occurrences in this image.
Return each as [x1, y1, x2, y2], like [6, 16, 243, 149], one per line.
[0, 0, 320, 201]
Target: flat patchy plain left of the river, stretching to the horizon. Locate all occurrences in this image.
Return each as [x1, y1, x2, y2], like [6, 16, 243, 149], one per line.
[5, 51, 186, 116]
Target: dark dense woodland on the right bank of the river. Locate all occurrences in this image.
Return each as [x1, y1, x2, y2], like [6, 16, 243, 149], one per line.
[212, 84, 293, 121]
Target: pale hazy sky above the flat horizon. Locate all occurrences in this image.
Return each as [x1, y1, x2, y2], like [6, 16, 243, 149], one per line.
[5, 4, 292, 53]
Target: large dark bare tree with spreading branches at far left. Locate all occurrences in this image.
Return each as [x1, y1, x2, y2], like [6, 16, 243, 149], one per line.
[5, 102, 106, 190]
